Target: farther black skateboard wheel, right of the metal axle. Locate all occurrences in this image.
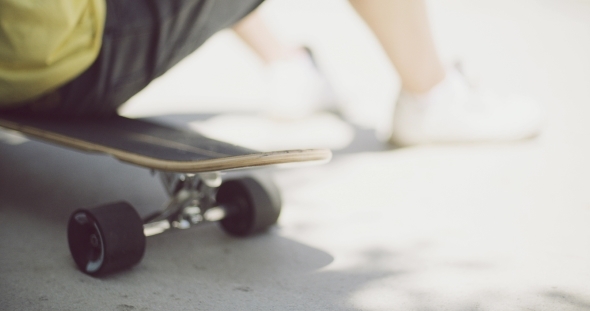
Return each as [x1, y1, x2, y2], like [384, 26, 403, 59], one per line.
[217, 177, 281, 236]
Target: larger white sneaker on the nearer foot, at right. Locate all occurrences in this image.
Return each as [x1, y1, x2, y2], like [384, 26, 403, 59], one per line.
[391, 70, 544, 146]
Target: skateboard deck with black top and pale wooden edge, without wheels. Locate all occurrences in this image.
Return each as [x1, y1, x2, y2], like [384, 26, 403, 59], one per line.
[0, 114, 332, 173]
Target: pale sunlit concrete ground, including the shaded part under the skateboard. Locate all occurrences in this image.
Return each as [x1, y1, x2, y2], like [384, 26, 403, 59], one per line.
[0, 0, 590, 310]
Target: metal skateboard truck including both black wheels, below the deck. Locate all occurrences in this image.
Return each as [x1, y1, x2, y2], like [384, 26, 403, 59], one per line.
[68, 171, 281, 276]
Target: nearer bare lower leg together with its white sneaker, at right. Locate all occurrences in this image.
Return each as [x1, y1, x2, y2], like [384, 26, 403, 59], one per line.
[350, 0, 543, 145]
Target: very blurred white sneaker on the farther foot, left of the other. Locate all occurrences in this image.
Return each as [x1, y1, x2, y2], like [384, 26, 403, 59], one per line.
[268, 49, 336, 119]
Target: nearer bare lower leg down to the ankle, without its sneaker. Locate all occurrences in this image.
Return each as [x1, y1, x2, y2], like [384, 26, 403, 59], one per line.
[350, 0, 445, 93]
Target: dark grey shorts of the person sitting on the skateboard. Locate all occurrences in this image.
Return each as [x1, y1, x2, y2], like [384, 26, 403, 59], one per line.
[8, 0, 263, 116]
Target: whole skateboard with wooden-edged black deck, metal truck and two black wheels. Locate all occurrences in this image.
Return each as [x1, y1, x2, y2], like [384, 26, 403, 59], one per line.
[0, 114, 332, 276]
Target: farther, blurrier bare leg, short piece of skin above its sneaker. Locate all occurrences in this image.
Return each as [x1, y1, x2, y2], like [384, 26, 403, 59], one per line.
[232, 11, 305, 64]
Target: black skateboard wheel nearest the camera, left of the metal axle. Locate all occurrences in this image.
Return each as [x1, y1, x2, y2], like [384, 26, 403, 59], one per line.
[68, 202, 145, 276]
